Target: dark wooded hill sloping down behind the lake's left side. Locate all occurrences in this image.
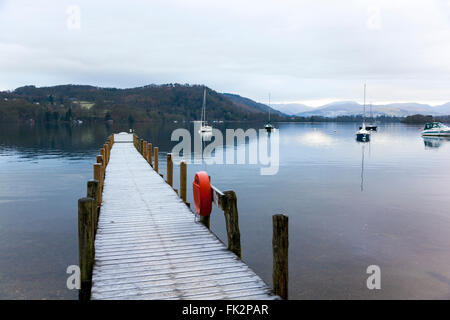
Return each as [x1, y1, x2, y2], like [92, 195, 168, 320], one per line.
[0, 84, 287, 123]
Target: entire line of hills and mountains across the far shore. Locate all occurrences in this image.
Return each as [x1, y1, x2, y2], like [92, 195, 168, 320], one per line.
[0, 84, 450, 122]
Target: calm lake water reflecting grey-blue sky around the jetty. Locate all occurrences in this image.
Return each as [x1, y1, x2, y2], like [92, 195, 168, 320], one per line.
[0, 123, 450, 299]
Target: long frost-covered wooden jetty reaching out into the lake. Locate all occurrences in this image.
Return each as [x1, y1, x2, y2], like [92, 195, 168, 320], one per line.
[79, 133, 287, 300]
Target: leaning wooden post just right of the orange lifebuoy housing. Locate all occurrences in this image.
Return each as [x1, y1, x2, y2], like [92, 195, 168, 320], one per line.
[223, 191, 241, 259]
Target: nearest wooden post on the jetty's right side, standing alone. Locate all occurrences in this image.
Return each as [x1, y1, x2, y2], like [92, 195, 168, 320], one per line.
[272, 214, 289, 300]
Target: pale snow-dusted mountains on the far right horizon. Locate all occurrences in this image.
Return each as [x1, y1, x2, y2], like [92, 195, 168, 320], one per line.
[274, 101, 450, 118]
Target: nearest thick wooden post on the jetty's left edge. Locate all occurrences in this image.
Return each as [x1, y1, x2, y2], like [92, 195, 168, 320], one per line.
[78, 198, 96, 300]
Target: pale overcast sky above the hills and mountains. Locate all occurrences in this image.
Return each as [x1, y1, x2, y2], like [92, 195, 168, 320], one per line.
[0, 0, 450, 106]
